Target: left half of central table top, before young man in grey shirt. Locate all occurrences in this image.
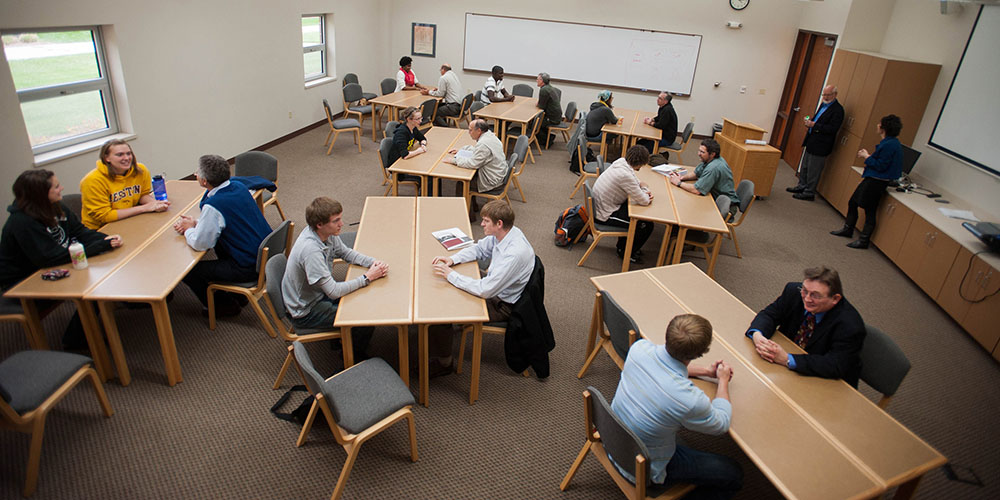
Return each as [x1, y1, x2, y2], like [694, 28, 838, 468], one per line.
[333, 196, 417, 326]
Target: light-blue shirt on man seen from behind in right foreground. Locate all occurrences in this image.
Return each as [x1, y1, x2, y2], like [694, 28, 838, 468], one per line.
[611, 339, 733, 483]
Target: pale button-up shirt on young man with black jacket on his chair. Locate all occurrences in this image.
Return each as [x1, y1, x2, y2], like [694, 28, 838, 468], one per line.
[448, 226, 535, 304]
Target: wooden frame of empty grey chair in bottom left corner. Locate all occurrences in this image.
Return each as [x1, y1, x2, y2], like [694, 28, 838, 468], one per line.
[0, 363, 114, 497]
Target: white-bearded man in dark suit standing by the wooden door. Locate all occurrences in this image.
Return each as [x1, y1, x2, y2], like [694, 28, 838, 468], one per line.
[785, 85, 844, 201]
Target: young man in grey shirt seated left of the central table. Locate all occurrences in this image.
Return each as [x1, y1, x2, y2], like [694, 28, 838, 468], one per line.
[281, 196, 389, 358]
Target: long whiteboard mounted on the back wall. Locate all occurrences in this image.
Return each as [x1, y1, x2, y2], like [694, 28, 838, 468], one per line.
[464, 13, 701, 95]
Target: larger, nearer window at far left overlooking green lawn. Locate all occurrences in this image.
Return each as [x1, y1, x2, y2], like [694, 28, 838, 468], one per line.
[2, 26, 118, 154]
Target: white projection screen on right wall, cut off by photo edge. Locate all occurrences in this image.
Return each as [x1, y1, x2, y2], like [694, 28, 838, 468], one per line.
[929, 6, 1000, 175]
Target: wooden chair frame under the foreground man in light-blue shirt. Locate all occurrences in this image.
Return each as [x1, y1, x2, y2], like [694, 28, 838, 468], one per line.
[559, 391, 694, 500]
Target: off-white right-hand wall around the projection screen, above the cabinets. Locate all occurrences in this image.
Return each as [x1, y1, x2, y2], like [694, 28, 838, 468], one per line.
[881, 0, 1000, 215]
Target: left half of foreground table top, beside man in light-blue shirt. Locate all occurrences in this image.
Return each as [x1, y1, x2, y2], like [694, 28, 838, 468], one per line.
[591, 270, 900, 498]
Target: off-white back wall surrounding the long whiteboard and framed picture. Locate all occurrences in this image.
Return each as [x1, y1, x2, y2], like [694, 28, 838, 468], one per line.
[383, 0, 811, 141]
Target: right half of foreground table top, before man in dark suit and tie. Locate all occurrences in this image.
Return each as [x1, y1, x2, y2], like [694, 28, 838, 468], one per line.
[647, 264, 945, 487]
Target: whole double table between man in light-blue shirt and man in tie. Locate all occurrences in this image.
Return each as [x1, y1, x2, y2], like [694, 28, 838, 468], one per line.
[587, 263, 946, 498]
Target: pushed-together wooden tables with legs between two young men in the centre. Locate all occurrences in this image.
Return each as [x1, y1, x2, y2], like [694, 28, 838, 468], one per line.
[334, 197, 489, 406]
